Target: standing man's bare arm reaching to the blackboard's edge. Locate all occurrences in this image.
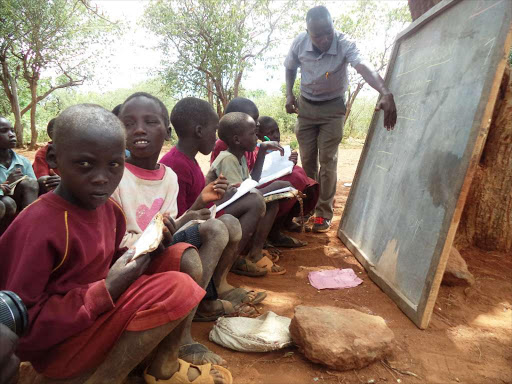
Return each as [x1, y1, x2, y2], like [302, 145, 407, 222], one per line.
[354, 62, 396, 131]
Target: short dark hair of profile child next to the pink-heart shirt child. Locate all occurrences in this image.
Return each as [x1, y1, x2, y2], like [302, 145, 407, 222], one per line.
[171, 97, 218, 137]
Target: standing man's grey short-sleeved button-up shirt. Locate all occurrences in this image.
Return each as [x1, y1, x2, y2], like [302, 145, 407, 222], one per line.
[284, 31, 363, 101]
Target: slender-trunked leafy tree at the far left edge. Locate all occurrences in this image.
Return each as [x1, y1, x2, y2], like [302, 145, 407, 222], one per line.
[0, 0, 114, 148]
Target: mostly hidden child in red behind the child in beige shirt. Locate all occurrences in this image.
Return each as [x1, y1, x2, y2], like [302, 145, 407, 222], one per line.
[216, 97, 314, 248]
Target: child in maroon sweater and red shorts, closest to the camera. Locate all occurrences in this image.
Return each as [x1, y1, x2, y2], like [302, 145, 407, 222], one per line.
[0, 104, 232, 384]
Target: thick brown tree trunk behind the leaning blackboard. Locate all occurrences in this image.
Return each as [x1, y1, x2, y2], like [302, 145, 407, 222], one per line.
[408, 0, 512, 252]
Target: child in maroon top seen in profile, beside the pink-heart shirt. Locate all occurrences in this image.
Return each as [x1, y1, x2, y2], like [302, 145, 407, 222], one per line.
[160, 97, 276, 280]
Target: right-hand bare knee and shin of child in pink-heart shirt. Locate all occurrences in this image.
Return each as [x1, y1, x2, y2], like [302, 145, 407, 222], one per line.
[213, 215, 242, 295]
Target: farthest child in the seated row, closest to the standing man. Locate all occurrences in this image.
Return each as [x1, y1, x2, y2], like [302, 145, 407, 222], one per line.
[257, 116, 320, 234]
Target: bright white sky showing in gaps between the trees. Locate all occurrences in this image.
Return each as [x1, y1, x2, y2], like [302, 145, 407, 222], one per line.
[86, 0, 410, 93]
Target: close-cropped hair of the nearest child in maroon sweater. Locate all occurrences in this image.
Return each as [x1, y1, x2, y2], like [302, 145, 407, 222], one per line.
[53, 104, 125, 148]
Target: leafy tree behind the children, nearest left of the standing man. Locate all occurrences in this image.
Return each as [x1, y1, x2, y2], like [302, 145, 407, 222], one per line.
[144, 0, 293, 115]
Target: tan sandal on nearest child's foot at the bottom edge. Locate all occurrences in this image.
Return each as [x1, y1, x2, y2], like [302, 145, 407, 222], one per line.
[144, 359, 233, 384]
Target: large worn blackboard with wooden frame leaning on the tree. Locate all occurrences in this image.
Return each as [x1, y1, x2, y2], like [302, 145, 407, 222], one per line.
[338, 0, 512, 328]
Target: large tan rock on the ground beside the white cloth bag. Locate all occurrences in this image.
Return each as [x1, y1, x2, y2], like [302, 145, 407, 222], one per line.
[290, 305, 395, 370]
